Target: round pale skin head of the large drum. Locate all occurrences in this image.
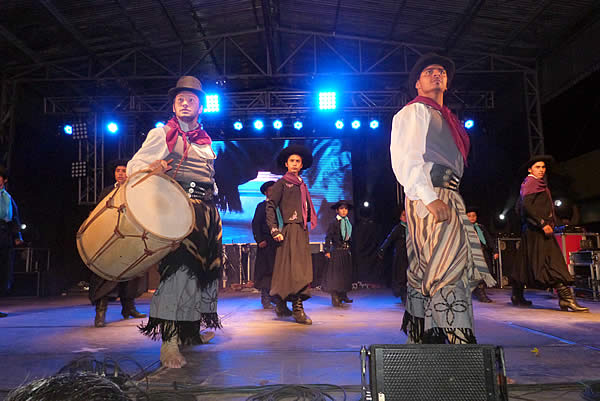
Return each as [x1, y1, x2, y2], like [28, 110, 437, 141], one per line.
[125, 173, 194, 240]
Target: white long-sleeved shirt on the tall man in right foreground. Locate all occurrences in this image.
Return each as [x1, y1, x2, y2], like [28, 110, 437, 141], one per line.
[390, 103, 464, 205]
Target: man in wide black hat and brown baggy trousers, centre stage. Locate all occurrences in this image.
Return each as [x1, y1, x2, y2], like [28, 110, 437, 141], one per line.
[267, 145, 317, 324]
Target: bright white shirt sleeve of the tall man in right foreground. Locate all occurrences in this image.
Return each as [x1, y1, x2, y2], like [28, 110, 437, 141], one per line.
[390, 103, 438, 205]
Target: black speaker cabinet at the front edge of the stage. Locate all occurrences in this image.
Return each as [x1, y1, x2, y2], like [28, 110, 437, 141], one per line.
[369, 344, 508, 401]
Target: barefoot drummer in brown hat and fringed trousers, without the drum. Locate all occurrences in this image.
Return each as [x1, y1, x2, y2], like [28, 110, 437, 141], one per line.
[127, 76, 223, 368]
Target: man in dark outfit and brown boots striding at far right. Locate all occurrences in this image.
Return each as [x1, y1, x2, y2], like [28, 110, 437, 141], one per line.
[511, 155, 589, 312]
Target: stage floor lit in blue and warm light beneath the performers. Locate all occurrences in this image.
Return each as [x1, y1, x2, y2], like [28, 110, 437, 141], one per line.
[0, 290, 600, 400]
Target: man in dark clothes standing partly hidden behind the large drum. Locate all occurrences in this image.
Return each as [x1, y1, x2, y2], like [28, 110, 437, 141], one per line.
[89, 160, 146, 327]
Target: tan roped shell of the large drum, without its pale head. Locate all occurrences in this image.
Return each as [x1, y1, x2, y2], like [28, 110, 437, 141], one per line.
[77, 176, 194, 281]
